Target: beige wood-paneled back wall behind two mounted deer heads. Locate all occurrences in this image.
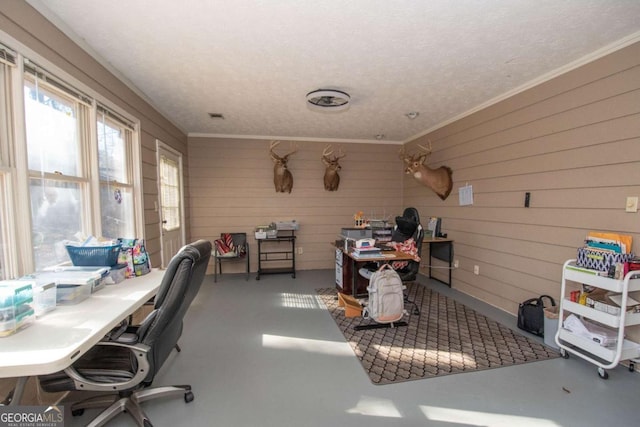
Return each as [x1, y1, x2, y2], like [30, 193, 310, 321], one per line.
[189, 137, 402, 274]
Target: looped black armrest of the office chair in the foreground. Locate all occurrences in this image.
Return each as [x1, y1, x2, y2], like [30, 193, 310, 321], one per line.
[64, 341, 151, 392]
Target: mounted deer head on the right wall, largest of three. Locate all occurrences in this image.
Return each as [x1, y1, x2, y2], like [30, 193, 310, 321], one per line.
[400, 141, 453, 200]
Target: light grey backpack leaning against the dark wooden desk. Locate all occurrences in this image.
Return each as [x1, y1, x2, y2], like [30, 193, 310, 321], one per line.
[362, 264, 405, 323]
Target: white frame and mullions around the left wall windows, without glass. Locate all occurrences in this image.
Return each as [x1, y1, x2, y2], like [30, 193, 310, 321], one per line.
[0, 30, 145, 278]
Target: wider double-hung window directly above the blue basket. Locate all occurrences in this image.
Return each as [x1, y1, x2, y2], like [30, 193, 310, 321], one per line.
[24, 66, 90, 269]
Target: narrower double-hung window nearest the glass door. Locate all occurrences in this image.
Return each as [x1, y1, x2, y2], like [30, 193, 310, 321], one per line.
[97, 107, 135, 238]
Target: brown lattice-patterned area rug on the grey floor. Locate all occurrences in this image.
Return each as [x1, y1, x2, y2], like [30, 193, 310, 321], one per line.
[316, 284, 560, 385]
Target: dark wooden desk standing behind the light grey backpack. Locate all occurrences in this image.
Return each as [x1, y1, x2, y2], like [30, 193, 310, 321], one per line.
[336, 246, 413, 297]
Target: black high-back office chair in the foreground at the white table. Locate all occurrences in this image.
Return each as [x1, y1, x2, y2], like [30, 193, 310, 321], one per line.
[39, 240, 212, 427]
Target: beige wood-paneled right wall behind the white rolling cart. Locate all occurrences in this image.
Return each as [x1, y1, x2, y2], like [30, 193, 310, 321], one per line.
[403, 43, 640, 324]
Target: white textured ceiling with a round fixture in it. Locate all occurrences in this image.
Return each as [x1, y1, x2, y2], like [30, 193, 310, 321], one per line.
[29, 0, 640, 142]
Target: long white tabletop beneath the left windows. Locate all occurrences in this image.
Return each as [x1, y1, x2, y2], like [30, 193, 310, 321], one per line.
[0, 269, 164, 378]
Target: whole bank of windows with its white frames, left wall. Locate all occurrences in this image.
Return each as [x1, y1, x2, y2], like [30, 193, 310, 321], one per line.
[0, 42, 144, 280]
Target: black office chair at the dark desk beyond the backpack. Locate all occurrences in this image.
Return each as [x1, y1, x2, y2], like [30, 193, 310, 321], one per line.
[391, 208, 424, 314]
